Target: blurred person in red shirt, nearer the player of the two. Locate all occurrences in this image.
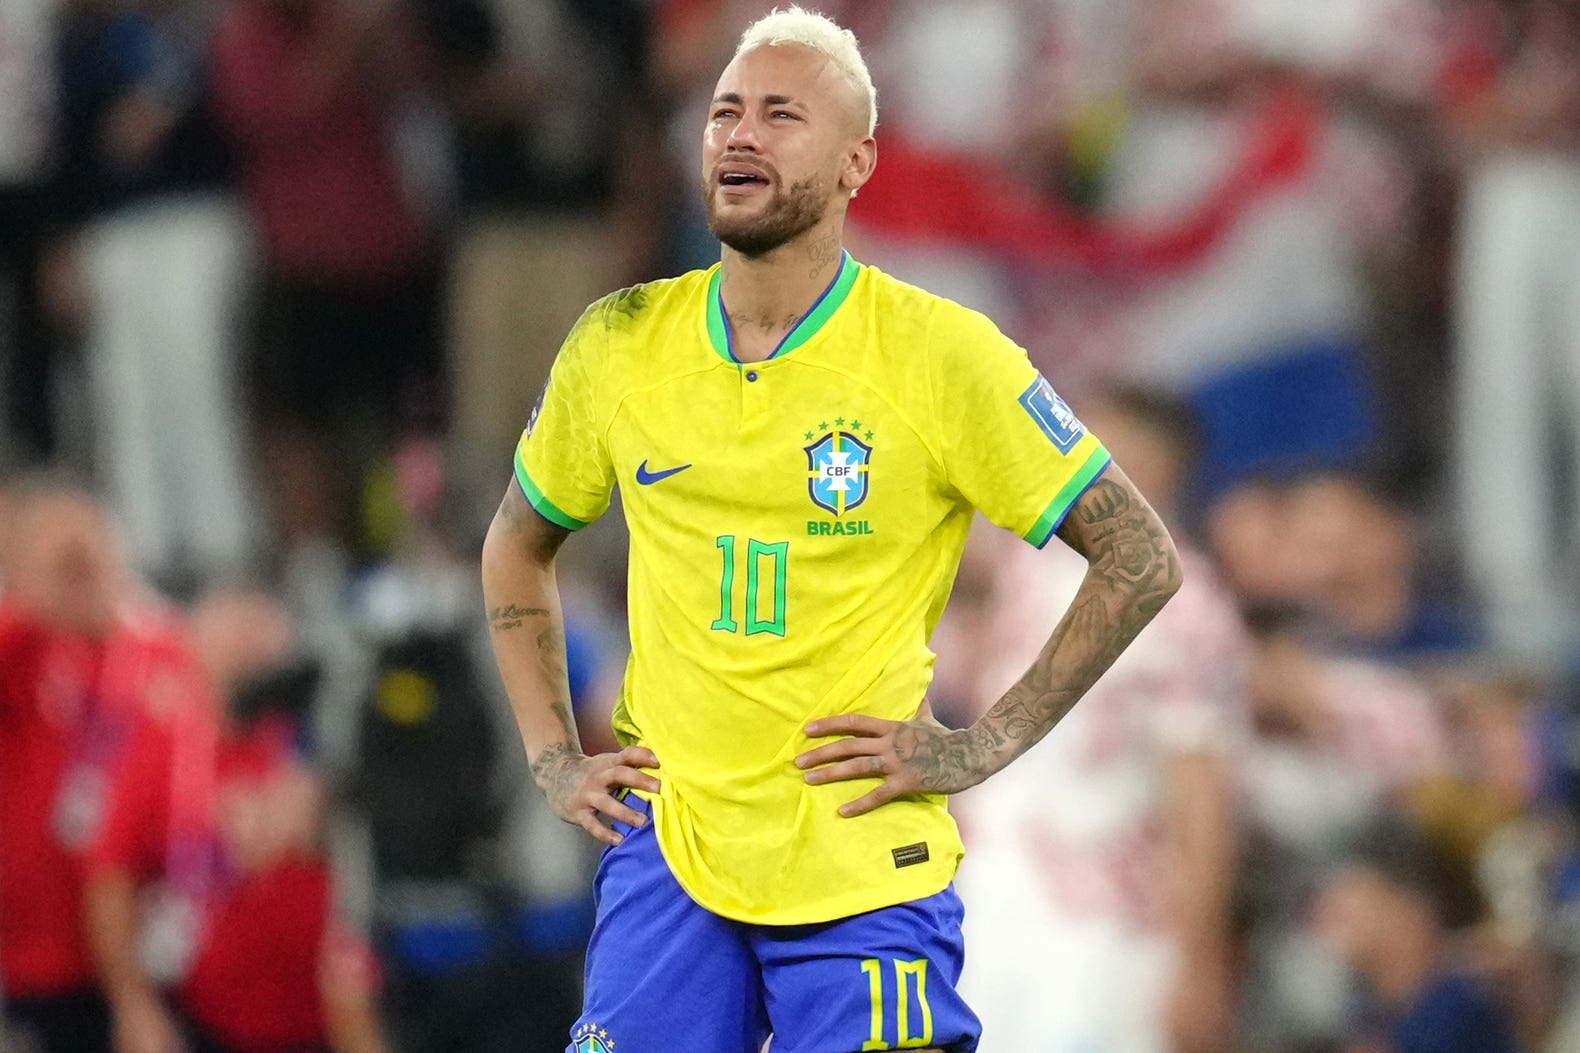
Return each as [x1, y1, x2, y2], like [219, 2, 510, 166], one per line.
[87, 590, 384, 1053]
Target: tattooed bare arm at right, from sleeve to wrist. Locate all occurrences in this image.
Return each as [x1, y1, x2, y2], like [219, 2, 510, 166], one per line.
[896, 471, 1180, 792]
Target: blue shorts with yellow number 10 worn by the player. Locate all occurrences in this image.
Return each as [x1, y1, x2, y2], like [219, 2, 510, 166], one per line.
[566, 795, 981, 1053]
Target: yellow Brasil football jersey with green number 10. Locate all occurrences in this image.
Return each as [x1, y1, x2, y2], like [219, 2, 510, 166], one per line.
[515, 256, 1109, 925]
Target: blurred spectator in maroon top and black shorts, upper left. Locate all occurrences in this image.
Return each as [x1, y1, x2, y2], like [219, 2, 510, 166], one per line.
[213, 0, 444, 566]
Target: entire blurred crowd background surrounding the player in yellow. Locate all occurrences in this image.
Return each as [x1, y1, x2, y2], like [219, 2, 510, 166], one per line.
[0, 0, 1580, 1053]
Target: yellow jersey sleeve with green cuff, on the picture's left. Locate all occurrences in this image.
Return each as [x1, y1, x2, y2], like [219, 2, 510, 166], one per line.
[515, 304, 615, 530]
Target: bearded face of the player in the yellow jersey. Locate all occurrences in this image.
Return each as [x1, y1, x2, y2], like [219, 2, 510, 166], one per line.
[702, 44, 867, 256]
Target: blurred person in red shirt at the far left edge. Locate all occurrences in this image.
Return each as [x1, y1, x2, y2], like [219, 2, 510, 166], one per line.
[0, 482, 191, 1053]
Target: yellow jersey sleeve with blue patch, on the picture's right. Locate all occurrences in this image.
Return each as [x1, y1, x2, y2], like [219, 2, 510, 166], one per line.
[927, 302, 1111, 549]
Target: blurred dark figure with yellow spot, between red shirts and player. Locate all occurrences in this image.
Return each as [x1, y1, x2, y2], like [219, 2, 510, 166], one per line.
[337, 446, 610, 1053]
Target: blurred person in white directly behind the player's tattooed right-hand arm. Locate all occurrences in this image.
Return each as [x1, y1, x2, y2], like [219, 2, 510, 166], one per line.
[953, 392, 1247, 1053]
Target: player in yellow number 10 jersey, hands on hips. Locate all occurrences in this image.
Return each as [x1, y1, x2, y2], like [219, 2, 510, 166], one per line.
[483, 8, 1180, 1053]
